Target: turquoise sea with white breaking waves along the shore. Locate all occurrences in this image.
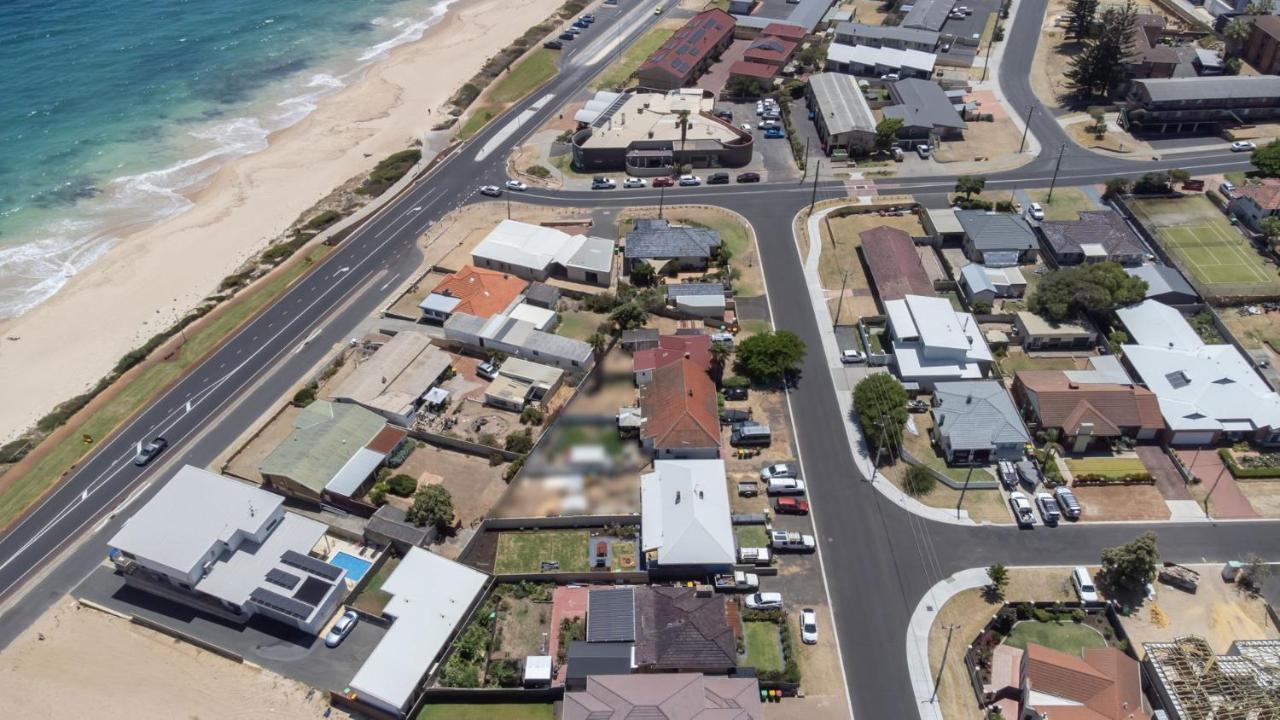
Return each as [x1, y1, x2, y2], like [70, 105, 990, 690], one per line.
[0, 0, 452, 318]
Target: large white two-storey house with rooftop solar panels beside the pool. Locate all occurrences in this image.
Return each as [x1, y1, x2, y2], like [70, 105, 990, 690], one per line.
[108, 465, 347, 635]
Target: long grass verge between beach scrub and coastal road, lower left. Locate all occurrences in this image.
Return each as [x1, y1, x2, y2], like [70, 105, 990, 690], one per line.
[0, 245, 333, 527]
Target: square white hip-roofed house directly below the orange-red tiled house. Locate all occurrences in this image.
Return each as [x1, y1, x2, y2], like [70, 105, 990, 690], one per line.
[640, 460, 733, 566]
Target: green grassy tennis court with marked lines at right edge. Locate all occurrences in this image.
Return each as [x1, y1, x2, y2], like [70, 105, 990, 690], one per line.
[1129, 196, 1280, 297]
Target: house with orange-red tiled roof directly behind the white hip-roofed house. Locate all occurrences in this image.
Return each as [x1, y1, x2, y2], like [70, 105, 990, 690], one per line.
[640, 357, 721, 460]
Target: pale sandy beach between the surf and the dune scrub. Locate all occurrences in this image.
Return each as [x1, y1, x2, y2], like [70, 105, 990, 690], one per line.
[0, 0, 561, 442]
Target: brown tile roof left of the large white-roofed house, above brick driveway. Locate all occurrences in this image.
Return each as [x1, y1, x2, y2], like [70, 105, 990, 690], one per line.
[1015, 370, 1165, 436]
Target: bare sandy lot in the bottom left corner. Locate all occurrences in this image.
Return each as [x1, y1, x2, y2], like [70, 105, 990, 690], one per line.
[0, 600, 347, 720]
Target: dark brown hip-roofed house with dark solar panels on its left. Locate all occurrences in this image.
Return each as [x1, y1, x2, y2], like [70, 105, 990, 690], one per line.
[636, 585, 737, 682]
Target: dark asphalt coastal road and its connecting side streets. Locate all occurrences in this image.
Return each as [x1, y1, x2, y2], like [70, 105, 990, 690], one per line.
[0, 0, 1280, 720]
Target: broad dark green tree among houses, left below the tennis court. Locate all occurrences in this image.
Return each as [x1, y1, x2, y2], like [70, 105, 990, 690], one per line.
[1027, 263, 1147, 323]
